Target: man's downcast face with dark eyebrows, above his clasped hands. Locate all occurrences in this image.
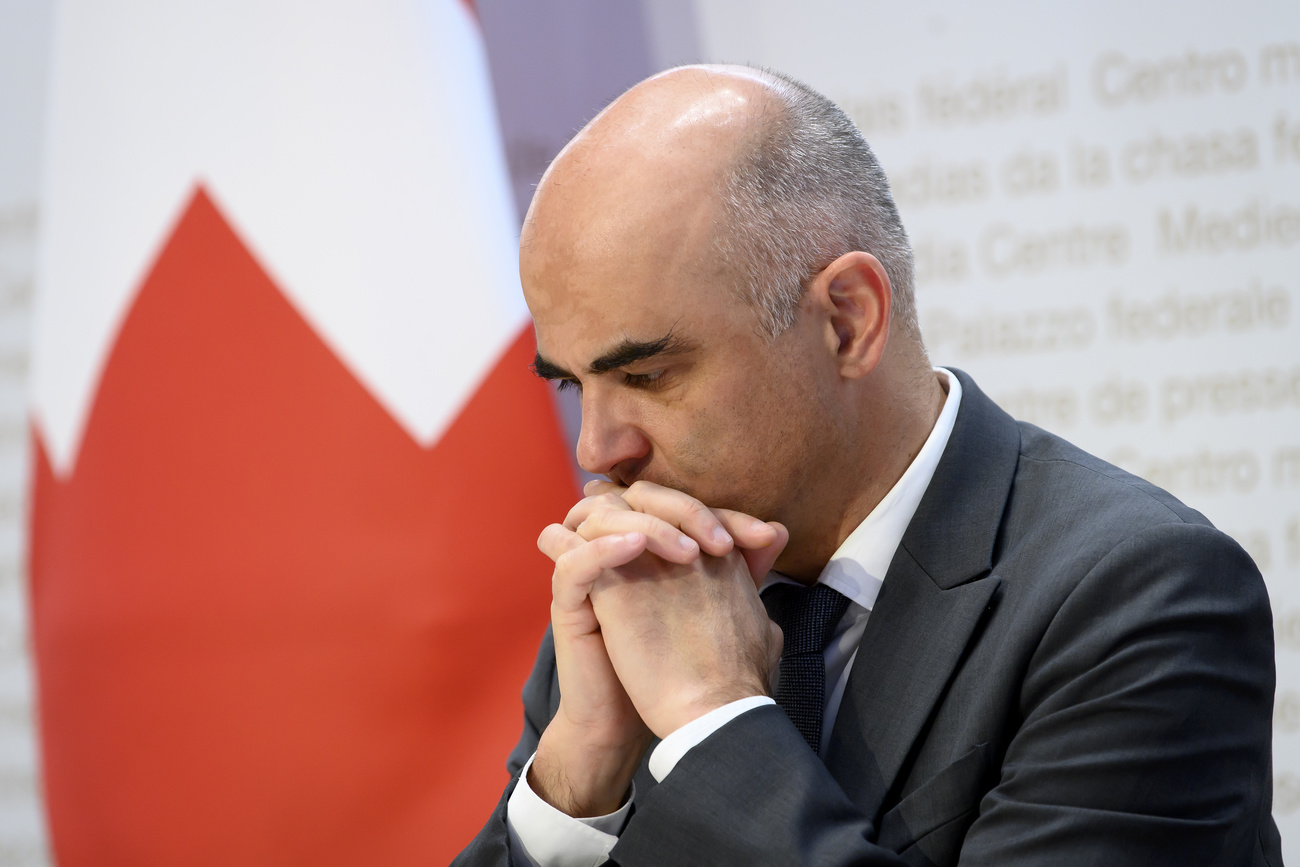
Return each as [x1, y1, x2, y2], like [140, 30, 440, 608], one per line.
[521, 203, 832, 530]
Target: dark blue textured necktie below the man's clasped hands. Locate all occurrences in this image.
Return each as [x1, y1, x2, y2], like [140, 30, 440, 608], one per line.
[763, 584, 849, 754]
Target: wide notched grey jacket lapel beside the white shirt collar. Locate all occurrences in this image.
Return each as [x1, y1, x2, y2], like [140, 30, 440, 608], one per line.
[826, 370, 1019, 819]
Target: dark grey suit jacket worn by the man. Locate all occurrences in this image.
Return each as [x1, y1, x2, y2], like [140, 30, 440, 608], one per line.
[456, 372, 1282, 867]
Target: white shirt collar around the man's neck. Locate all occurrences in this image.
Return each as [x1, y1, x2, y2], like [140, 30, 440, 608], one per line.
[763, 368, 962, 611]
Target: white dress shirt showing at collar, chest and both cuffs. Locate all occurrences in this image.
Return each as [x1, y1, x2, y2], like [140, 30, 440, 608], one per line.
[506, 368, 962, 867]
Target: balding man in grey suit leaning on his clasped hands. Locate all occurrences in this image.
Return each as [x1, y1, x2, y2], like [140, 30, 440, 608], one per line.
[459, 66, 1281, 867]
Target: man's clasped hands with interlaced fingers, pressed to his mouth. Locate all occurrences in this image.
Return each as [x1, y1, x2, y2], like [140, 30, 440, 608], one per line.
[529, 481, 789, 816]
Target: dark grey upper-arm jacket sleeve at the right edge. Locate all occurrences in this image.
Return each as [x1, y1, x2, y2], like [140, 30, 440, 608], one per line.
[961, 524, 1281, 867]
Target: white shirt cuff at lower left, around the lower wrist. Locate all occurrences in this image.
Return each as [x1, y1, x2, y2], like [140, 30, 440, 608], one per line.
[506, 753, 636, 867]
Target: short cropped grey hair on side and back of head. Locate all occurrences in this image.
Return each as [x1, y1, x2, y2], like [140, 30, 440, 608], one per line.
[714, 69, 920, 339]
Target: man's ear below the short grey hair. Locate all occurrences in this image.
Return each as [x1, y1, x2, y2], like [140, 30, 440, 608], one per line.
[809, 251, 892, 380]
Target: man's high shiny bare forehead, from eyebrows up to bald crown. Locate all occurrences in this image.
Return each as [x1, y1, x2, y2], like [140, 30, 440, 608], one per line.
[520, 75, 769, 370]
